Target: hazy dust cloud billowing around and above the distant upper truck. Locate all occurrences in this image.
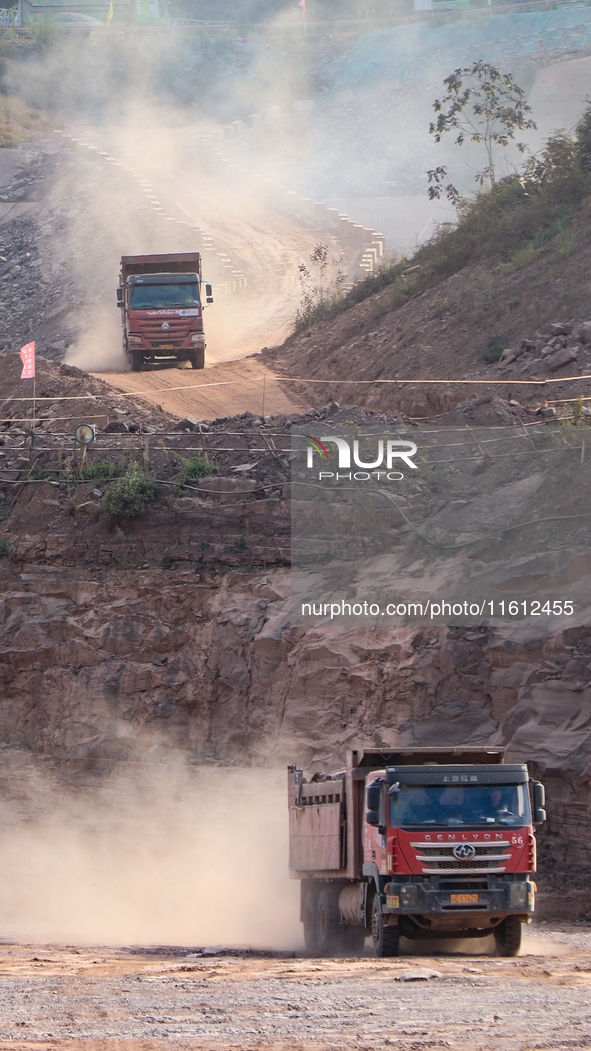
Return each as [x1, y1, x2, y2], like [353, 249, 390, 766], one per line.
[11, 25, 332, 370]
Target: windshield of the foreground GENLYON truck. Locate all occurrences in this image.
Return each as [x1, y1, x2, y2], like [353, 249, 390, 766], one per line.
[389, 785, 531, 828]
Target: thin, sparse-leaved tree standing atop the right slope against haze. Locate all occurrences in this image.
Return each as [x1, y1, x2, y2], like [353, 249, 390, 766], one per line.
[427, 62, 536, 204]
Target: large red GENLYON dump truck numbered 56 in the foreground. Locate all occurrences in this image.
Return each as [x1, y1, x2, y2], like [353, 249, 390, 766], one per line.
[288, 747, 546, 956]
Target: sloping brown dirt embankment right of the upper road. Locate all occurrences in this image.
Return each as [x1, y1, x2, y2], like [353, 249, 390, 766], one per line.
[263, 222, 591, 417]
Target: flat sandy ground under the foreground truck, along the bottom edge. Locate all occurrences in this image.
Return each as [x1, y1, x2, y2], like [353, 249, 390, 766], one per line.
[0, 925, 591, 1051]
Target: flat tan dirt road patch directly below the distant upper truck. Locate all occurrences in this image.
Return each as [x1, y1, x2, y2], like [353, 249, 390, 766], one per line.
[93, 357, 307, 419]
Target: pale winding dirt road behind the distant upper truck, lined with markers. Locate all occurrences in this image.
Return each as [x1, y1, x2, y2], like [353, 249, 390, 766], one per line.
[67, 124, 363, 362]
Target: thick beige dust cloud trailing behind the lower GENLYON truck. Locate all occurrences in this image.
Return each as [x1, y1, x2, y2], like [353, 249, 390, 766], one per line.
[0, 763, 301, 949]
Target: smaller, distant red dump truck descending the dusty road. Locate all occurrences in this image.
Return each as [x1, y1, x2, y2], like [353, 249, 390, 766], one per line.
[117, 252, 213, 372]
